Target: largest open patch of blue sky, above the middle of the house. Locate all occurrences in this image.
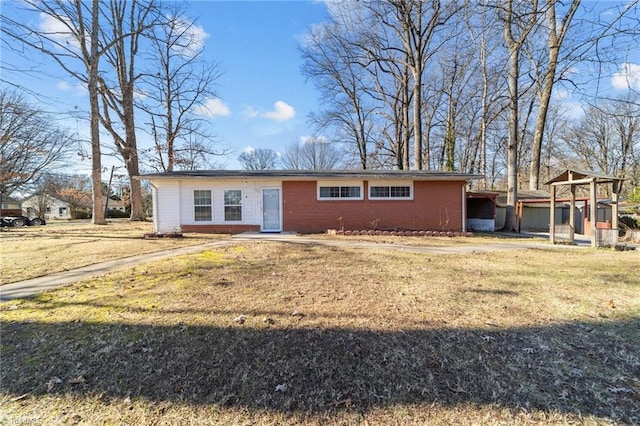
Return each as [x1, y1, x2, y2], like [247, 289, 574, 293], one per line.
[190, 1, 327, 168]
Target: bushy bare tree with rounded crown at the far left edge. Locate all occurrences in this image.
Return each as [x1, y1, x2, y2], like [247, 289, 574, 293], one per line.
[0, 89, 77, 203]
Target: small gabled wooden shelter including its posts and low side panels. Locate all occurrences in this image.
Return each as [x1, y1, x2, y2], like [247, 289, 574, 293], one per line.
[546, 170, 624, 247]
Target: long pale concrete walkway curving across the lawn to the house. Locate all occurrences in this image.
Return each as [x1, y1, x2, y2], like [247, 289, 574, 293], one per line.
[0, 233, 576, 301]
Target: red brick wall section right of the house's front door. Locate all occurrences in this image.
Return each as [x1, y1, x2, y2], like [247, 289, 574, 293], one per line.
[282, 181, 465, 232]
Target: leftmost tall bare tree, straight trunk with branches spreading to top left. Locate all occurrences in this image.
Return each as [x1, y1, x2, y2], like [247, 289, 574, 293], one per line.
[0, 0, 106, 224]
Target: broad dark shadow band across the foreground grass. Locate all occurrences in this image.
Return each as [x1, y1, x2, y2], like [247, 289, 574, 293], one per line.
[1, 318, 640, 424]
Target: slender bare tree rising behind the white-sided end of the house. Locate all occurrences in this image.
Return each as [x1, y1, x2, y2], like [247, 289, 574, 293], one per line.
[139, 9, 226, 172]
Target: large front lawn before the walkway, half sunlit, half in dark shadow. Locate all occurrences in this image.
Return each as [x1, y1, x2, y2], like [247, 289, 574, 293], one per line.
[0, 235, 640, 425]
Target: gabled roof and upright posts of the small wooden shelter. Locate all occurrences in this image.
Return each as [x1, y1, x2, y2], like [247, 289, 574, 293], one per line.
[546, 170, 624, 247]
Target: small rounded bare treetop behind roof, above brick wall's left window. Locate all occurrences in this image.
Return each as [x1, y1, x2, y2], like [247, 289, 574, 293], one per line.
[280, 136, 342, 170]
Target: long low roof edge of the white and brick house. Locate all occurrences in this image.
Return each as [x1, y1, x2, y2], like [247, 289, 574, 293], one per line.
[135, 170, 482, 181]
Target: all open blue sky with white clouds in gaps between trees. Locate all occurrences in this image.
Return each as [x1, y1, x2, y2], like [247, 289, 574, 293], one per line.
[0, 0, 640, 173]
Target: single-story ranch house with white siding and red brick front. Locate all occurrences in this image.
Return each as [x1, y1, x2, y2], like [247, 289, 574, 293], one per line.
[137, 170, 480, 233]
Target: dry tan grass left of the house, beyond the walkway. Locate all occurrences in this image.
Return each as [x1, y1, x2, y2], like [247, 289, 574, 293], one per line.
[0, 221, 226, 284]
